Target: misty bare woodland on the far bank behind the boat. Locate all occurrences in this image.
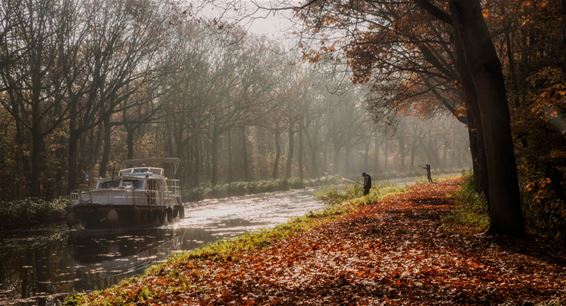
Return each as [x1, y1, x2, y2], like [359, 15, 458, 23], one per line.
[0, 0, 469, 199]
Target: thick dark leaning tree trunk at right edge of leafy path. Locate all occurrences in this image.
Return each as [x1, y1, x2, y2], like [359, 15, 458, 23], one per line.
[449, 0, 525, 235]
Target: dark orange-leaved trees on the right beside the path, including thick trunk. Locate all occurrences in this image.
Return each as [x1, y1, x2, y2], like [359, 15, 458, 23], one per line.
[298, 0, 566, 235]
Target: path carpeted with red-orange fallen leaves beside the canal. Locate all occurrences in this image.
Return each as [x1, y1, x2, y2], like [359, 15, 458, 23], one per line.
[86, 181, 566, 305]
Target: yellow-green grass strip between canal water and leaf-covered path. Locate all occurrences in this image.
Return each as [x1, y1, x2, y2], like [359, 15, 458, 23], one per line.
[64, 180, 406, 305]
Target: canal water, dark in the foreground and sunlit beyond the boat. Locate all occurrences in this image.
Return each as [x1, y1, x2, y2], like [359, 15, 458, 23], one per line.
[0, 189, 324, 305]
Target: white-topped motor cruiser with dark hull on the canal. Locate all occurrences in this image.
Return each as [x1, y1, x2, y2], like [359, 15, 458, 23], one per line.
[67, 158, 185, 229]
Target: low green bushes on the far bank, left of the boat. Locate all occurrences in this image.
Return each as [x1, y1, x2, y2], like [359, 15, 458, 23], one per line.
[0, 198, 70, 229]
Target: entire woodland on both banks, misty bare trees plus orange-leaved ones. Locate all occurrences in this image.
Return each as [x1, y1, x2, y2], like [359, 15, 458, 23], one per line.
[0, 0, 566, 235]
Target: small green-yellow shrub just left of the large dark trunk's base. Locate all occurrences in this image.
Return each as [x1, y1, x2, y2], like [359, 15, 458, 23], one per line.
[443, 176, 489, 231]
